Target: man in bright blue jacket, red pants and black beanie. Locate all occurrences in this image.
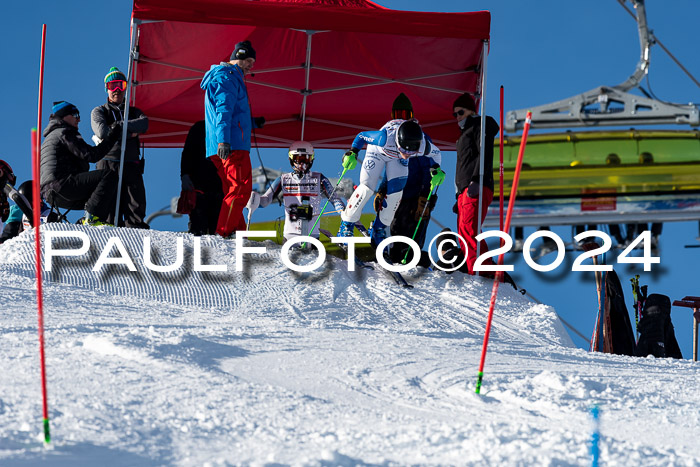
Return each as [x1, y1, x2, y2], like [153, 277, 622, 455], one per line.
[200, 41, 265, 237]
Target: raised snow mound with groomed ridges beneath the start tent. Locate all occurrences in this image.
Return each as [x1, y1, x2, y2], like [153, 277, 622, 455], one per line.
[0, 224, 573, 346]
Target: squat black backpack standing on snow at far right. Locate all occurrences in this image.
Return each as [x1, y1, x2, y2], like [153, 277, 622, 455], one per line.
[635, 294, 683, 358]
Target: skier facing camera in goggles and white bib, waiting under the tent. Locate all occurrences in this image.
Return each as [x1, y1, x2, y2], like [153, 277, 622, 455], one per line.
[246, 141, 345, 240]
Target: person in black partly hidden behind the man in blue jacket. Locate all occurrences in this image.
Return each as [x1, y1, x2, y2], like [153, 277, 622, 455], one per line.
[180, 120, 224, 235]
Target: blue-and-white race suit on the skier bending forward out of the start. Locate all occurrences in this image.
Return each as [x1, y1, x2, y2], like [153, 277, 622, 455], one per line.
[340, 119, 442, 226]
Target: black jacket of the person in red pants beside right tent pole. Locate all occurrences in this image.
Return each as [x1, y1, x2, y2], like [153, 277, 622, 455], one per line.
[455, 116, 499, 195]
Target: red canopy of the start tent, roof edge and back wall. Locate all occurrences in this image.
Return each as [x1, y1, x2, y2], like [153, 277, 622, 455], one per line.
[132, 0, 490, 149]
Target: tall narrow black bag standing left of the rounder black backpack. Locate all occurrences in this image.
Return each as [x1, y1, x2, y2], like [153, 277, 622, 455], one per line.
[605, 271, 634, 356]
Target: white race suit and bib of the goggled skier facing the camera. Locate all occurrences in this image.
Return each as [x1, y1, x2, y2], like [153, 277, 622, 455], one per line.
[260, 172, 345, 240]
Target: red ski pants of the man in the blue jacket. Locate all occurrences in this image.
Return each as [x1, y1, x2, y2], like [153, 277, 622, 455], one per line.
[211, 149, 253, 237]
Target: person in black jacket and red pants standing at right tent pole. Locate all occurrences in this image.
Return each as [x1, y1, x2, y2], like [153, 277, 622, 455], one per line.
[452, 93, 499, 275]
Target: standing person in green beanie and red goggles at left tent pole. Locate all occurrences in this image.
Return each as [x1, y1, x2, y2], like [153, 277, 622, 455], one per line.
[90, 67, 149, 229]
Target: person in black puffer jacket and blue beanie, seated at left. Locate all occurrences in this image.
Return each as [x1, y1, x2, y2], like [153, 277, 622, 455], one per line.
[40, 101, 121, 225]
